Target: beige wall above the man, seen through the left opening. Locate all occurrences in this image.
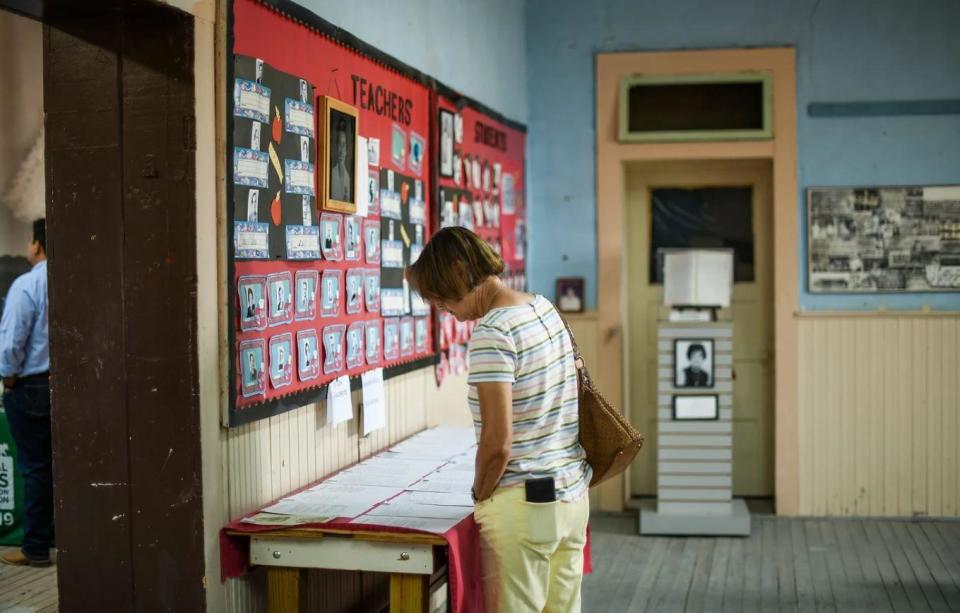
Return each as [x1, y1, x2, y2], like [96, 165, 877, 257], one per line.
[0, 11, 45, 255]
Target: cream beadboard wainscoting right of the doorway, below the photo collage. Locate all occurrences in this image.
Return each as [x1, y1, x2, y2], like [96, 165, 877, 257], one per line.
[798, 313, 960, 517]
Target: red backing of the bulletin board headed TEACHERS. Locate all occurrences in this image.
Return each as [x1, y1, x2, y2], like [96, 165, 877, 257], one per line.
[227, 0, 436, 426]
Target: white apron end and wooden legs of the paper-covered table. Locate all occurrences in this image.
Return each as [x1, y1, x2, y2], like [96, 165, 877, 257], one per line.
[230, 528, 447, 613]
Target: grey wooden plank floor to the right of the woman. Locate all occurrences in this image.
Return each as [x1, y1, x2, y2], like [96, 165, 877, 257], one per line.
[583, 506, 960, 613]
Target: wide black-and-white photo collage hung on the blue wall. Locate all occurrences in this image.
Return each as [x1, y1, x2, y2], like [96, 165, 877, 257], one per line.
[807, 185, 960, 293]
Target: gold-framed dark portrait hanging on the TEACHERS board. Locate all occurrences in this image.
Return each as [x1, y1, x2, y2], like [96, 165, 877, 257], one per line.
[317, 96, 366, 213]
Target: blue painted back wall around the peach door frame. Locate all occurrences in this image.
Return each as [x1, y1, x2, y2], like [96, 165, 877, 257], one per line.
[526, 0, 960, 310]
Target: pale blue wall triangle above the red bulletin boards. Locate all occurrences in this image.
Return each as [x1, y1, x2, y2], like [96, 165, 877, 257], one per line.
[296, 0, 527, 122]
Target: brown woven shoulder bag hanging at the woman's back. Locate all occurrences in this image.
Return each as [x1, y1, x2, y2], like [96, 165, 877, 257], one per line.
[557, 311, 643, 487]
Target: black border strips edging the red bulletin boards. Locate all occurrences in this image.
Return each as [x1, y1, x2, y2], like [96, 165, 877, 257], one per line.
[224, 0, 527, 428]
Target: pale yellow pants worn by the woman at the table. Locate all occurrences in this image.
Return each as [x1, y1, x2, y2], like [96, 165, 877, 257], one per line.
[474, 487, 590, 613]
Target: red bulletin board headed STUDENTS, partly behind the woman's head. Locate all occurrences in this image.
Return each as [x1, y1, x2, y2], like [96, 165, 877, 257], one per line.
[433, 86, 526, 382]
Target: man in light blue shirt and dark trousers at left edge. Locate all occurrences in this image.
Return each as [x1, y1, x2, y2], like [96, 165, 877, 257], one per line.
[0, 219, 53, 566]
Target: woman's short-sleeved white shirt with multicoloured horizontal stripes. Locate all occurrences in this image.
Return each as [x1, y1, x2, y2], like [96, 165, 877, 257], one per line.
[467, 296, 592, 501]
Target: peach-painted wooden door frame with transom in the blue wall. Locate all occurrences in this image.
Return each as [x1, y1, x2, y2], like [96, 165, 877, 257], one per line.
[596, 47, 800, 515]
